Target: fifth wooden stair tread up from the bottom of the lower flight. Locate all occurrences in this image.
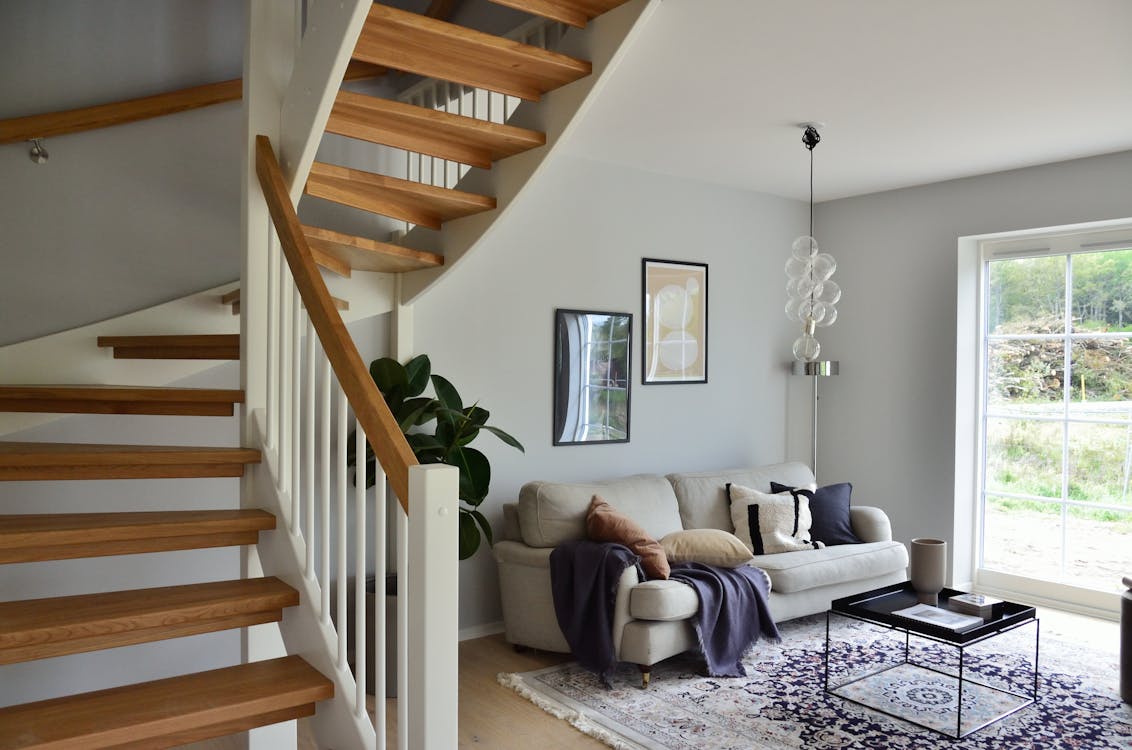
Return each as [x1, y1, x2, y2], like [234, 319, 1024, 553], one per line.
[0, 385, 243, 416]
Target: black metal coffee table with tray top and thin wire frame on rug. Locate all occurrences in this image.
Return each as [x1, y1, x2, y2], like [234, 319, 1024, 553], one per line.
[824, 581, 1039, 739]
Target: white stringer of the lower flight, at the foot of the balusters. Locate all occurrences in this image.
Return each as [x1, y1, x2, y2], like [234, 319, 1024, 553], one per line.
[245, 434, 374, 748]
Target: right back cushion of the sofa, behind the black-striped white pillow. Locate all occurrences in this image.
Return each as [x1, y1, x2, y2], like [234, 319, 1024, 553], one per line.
[667, 462, 814, 534]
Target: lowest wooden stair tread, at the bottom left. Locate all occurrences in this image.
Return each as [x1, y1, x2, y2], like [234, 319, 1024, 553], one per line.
[0, 656, 334, 750]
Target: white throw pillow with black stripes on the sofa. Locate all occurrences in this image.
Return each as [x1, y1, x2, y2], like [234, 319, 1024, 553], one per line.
[727, 484, 825, 555]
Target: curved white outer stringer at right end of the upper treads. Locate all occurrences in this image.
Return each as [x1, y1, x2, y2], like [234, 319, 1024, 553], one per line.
[401, 0, 661, 305]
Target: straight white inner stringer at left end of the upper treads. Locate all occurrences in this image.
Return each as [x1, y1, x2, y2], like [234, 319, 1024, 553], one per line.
[277, 0, 374, 205]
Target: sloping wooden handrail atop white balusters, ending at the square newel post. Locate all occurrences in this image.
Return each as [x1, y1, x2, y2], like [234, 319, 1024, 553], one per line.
[256, 136, 418, 512]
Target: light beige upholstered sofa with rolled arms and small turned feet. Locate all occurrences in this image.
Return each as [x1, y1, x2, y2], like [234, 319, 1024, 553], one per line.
[495, 463, 908, 684]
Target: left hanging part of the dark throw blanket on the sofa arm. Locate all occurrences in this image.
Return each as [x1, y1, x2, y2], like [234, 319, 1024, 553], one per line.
[550, 541, 644, 684]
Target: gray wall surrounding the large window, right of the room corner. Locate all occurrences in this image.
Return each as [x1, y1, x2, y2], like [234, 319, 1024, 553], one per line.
[816, 152, 1132, 563]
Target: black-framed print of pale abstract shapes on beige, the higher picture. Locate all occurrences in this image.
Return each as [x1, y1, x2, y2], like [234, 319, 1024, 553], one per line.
[641, 258, 708, 386]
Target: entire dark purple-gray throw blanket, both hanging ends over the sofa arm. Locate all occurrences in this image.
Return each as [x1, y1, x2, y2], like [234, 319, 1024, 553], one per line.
[550, 542, 779, 684]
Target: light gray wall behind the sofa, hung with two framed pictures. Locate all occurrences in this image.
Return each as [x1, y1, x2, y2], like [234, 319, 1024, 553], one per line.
[414, 156, 808, 628]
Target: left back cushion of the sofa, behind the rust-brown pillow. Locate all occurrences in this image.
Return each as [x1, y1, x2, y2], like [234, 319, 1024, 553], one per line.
[518, 474, 683, 546]
